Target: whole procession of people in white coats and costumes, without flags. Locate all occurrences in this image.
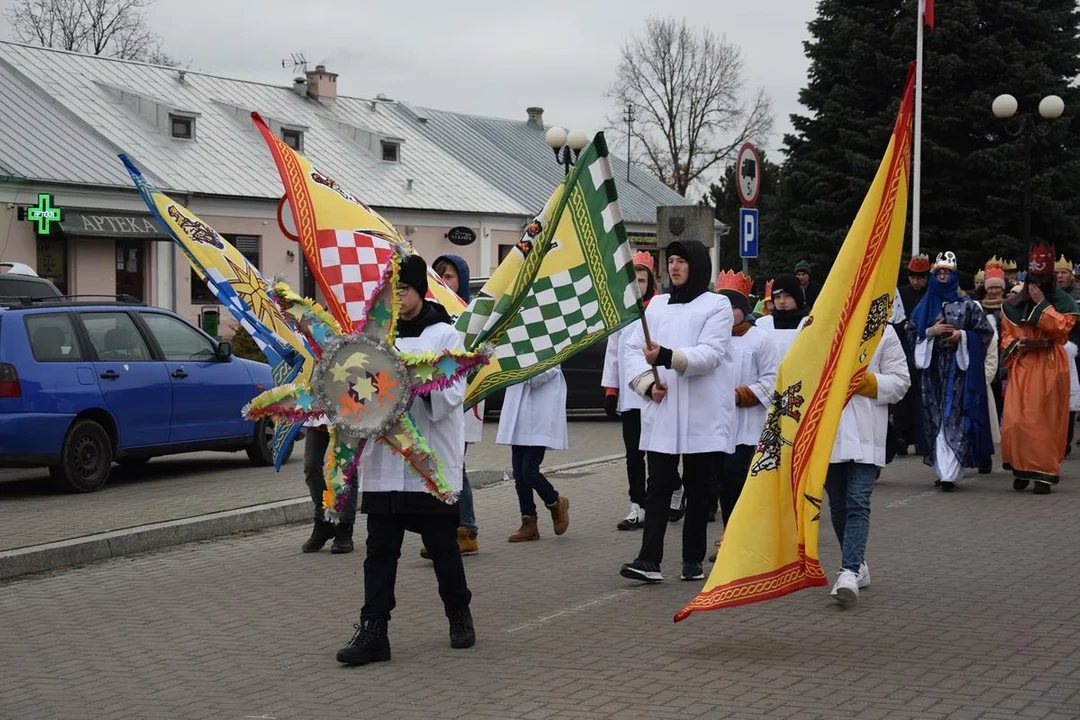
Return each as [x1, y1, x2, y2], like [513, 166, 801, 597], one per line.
[302, 241, 1080, 665]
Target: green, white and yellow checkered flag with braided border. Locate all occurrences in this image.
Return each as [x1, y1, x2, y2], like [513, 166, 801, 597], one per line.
[457, 133, 644, 407]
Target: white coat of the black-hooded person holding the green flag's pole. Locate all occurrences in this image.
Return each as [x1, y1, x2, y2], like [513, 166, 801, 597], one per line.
[622, 293, 735, 454]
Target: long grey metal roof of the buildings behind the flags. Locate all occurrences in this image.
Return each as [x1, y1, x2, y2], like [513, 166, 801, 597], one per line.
[0, 42, 687, 223]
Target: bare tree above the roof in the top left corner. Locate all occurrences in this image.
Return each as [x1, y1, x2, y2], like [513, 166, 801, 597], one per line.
[4, 0, 177, 65]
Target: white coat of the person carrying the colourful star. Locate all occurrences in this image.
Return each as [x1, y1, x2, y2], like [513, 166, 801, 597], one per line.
[360, 323, 465, 492]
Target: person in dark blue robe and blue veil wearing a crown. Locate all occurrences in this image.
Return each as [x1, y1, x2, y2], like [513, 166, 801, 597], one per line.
[907, 252, 989, 491]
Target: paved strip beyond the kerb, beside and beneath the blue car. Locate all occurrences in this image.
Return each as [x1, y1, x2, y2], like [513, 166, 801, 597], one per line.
[0, 419, 622, 551]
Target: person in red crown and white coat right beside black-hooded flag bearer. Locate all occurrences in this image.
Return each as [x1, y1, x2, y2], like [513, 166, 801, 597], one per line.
[713, 270, 780, 527]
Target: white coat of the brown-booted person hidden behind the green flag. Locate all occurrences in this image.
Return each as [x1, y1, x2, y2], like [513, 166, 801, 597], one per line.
[495, 366, 570, 450]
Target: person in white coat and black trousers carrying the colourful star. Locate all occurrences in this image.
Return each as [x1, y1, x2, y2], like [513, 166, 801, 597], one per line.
[337, 255, 476, 665]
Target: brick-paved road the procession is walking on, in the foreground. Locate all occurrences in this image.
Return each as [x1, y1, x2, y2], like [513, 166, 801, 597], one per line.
[0, 459, 1080, 720]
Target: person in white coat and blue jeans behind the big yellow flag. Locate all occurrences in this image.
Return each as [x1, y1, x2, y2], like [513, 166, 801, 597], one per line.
[825, 325, 912, 604]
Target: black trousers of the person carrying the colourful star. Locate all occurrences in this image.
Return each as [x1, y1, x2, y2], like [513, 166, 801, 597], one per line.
[360, 513, 472, 620]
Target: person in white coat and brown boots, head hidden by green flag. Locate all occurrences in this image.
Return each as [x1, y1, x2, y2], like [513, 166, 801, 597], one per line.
[495, 366, 570, 543]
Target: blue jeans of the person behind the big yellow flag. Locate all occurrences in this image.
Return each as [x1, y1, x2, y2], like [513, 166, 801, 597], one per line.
[825, 462, 877, 573]
